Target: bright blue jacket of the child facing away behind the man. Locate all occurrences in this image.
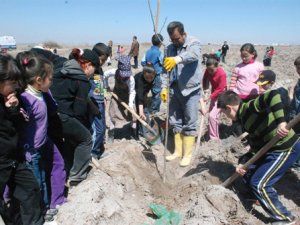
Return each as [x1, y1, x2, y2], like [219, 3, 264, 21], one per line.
[141, 45, 164, 74]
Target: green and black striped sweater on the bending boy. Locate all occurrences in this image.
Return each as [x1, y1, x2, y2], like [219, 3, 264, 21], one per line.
[237, 90, 298, 152]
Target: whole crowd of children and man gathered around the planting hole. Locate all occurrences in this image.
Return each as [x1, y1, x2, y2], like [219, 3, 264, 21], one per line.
[0, 21, 300, 225]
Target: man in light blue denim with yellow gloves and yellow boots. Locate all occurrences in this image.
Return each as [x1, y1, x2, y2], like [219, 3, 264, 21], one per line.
[162, 21, 202, 166]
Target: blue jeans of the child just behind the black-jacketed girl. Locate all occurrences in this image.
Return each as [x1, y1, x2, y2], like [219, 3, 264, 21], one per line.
[91, 103, 106, 157]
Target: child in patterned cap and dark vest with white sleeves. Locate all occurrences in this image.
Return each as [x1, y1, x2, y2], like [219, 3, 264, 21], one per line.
[104, 55, 136, 142]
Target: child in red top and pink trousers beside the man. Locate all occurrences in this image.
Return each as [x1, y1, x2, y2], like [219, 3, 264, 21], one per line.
[201, 57, 227, 140]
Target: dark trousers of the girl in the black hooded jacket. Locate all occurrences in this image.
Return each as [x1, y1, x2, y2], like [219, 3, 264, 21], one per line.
[59, 114, 92, 182]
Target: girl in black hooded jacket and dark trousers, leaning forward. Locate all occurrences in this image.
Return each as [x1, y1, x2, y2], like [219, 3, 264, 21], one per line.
[51, 49, 99, 186]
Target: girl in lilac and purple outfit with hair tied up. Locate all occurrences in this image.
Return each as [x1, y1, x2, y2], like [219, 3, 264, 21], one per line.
[17, 52, 66, 221]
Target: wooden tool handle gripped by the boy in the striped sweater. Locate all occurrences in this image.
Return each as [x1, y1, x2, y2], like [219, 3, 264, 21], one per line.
[222, 114, 300, 187]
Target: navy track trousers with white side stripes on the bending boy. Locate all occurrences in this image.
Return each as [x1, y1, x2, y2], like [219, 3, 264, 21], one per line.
[244, 142, 300, 221]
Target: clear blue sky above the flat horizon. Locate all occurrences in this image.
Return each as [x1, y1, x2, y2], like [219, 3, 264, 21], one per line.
[0, 0, 300, 45]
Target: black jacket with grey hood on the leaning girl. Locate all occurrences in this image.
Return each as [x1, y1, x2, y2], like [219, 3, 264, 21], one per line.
[50, 59, 91, 124]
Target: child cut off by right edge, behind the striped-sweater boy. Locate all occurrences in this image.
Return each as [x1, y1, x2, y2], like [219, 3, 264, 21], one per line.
[289, 56, 300, 172]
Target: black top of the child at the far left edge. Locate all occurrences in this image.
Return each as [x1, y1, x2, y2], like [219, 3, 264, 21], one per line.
[0, 96, 24, 169]
